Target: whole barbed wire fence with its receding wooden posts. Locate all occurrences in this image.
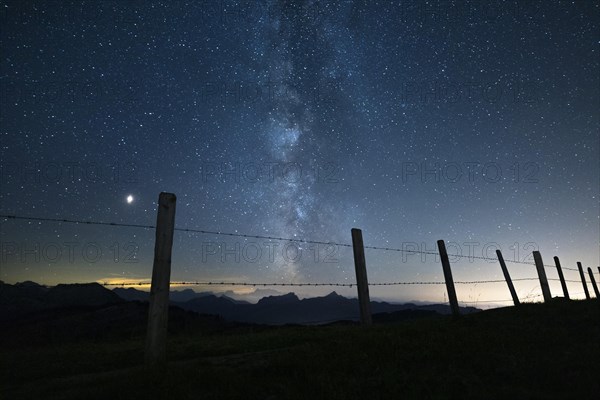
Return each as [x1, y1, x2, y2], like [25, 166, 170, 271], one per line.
[0, 193, 600, 366]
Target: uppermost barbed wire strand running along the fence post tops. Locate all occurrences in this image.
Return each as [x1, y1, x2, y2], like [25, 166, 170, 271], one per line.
[0, 214, 592, 272]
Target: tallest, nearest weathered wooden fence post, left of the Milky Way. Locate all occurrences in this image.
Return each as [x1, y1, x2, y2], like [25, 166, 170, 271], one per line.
[145, 192, 177, 369]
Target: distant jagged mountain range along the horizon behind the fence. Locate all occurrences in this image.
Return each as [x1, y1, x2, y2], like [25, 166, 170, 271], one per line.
[0, 282, 479, 324]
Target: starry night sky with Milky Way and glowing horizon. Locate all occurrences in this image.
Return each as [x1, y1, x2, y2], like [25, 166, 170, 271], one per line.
[0, 0, 600, 303]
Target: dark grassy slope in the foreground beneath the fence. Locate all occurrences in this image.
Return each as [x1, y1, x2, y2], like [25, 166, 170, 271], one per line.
[0, 300, 600, 400]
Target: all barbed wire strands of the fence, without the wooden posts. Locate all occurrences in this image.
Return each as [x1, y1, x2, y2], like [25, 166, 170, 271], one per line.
[0, 214, 596, 310]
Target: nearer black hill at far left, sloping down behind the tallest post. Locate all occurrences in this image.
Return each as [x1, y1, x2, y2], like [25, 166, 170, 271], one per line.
[0, 282, 227, 345]
